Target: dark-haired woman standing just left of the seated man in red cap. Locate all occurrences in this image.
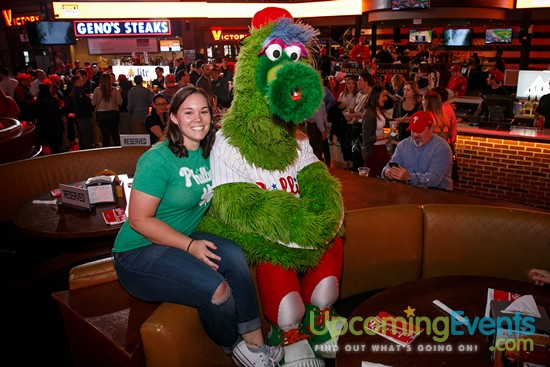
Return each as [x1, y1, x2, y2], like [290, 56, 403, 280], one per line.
[361, 85, 390, 177]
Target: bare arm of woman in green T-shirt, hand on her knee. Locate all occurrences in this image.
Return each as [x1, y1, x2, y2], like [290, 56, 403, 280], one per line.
[128, 189, 220, 269]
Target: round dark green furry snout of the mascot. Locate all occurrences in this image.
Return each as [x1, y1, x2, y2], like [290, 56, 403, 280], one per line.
[266, 61, 323, 124]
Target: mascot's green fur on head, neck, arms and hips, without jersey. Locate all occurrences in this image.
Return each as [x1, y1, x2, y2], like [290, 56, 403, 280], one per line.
[199, 13, 343, 271]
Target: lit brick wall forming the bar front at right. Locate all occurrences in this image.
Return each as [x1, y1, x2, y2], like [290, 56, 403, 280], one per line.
[454, 135, 550, 209]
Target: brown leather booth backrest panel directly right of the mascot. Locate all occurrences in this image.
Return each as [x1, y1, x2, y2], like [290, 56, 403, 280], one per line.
[341, 205, 422, 298]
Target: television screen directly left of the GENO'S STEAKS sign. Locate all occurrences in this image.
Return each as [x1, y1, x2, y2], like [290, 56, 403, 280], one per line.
[26, 21, 76, 46]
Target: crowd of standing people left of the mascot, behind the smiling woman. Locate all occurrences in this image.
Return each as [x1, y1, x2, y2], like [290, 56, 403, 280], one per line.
[0, 58, 233, 154]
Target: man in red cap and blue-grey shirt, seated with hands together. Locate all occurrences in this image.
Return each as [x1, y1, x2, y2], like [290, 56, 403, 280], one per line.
[382, 111, 453, 191]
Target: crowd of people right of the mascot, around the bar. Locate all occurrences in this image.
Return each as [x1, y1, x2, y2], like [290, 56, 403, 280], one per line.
[310, 40, 544, 190]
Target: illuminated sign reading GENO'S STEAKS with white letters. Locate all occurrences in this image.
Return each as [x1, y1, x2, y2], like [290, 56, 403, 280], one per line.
[74, 20, 172, 37]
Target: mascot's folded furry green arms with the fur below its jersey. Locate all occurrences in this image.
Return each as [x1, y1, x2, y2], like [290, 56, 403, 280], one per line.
[200, 162, 343, 268]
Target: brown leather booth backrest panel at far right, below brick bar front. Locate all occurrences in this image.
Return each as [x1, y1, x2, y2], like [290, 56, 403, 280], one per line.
[422, 204, 550, 281]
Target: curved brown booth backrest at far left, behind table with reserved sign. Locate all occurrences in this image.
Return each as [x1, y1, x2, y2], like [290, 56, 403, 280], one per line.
[0, 146, 149, 222]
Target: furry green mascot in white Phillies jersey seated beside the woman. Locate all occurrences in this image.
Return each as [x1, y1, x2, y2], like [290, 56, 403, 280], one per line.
[201, 8, 344, 367]
